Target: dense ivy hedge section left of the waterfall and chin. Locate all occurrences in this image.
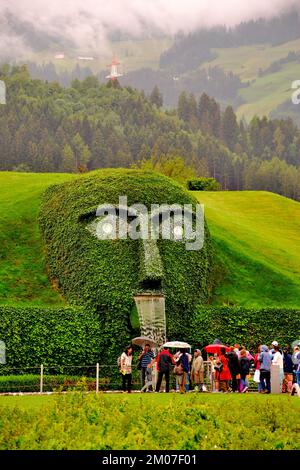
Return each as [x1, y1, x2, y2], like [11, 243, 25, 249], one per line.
[0, 305, 101, 374]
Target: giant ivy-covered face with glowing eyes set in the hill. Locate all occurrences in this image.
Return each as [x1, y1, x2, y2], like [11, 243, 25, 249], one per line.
[40, 170, 212, 342]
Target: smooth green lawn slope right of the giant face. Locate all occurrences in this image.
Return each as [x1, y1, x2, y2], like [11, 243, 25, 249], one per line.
[197, 191, 300, 307]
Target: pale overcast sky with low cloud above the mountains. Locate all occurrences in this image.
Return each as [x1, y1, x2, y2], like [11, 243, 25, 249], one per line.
[0, 0, 300, 56]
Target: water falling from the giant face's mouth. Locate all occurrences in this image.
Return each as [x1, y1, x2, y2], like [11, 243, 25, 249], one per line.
[134, 294, 166, 346]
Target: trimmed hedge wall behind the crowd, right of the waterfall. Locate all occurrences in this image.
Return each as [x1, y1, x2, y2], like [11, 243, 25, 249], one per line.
[169, 306, 300, 352]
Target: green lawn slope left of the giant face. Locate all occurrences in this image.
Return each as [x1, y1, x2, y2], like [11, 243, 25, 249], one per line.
[0, 172, 72, 305]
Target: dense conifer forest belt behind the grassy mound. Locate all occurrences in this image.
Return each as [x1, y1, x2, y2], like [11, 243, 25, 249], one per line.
[0, 66, 300, 200]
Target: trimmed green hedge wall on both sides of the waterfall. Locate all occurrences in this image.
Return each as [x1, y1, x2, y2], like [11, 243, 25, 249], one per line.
[0, 306, 300, 375]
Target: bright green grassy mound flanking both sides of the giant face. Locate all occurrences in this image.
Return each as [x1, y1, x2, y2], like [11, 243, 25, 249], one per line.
[0, 172, 300, 306]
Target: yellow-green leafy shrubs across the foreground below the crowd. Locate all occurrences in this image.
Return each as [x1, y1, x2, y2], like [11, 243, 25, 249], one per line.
[0, 393, 300, 453]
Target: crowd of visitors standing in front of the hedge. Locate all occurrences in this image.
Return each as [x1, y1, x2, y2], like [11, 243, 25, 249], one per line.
[119, 341, 300, 393]
